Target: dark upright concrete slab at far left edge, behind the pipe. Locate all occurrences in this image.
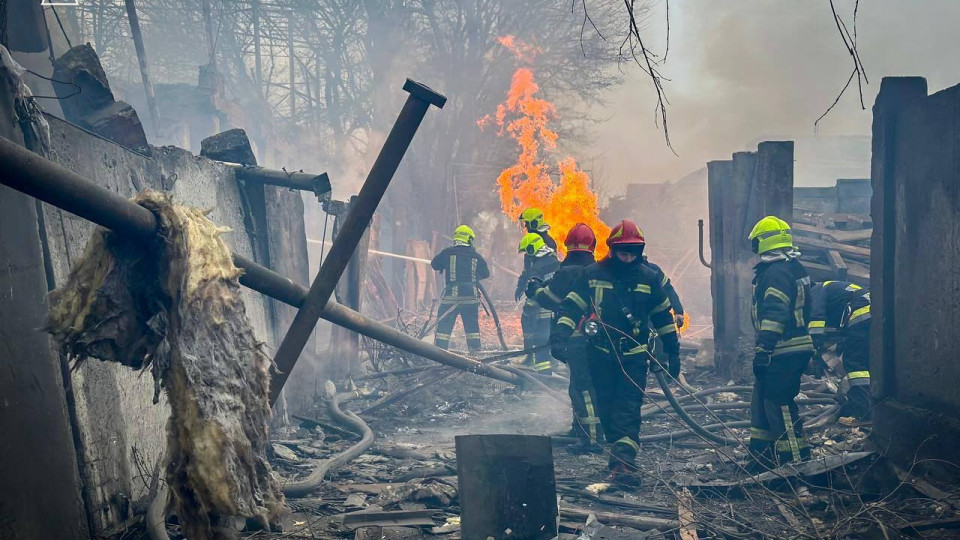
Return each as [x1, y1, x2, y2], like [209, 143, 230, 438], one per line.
[0, 69, 89, 539]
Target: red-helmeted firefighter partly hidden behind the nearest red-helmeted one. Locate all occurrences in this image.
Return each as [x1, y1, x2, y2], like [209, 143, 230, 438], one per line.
[527, 223, 603, 450]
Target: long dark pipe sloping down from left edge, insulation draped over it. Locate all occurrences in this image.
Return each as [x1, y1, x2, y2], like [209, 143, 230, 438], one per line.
[0, 137, 522, 384]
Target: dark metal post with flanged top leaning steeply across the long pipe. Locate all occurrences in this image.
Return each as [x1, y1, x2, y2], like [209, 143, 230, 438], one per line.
[270, 79, 447, 403]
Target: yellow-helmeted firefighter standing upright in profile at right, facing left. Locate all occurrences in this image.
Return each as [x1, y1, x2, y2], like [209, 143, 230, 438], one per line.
[748, 216, 814, 471]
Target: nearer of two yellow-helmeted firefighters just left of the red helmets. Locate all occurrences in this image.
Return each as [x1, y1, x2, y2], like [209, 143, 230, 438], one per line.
[516, 233, 560, 374]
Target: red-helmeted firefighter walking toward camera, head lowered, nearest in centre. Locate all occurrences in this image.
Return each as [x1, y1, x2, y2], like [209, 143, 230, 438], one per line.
[553, 220, 680, 485]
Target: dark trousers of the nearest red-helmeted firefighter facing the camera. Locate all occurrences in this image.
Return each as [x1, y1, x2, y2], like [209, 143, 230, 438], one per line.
[589, 346, 647, 469]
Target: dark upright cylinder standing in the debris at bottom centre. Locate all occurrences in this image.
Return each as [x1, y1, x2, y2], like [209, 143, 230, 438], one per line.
[456, 435, 557, 540]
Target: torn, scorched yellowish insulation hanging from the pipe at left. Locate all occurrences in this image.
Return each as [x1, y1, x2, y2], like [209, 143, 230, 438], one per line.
[48, 191, 286, 540]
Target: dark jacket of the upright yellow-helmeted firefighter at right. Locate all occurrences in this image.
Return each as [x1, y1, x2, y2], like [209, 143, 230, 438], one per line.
[753, 259, 814, 357]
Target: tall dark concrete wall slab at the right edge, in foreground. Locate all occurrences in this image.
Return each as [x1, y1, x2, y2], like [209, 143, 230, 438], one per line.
[871, 77, 960, 480]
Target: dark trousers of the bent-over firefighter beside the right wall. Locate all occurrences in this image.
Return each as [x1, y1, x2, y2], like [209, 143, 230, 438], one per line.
[838, 320, 871, 420]
